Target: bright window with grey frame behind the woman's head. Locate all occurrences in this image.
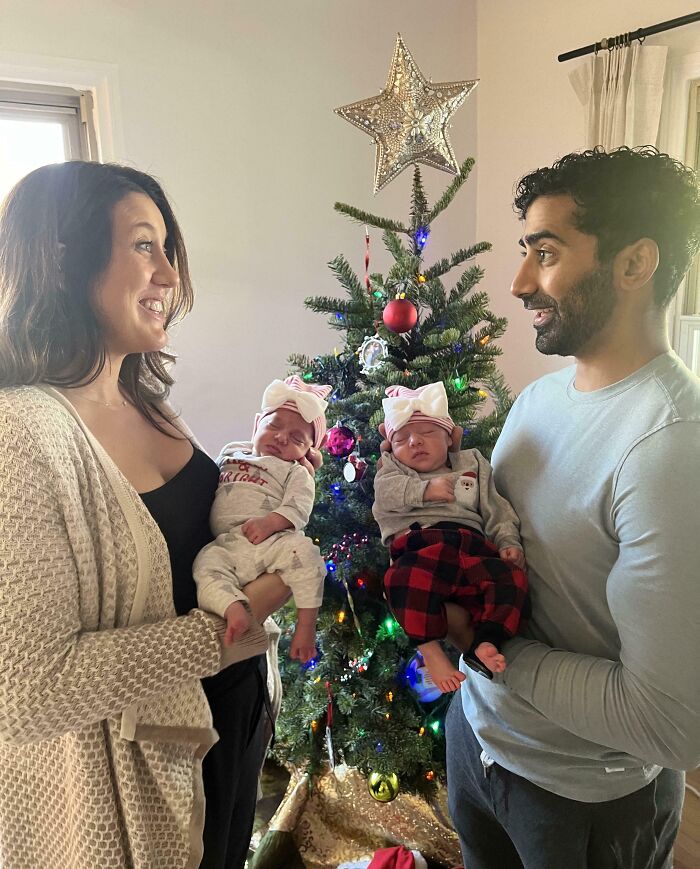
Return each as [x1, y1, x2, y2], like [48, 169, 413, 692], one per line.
[0, 82, 97, 201]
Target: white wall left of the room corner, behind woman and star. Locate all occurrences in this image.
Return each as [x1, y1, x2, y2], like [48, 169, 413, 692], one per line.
[0, 0, 476, 450]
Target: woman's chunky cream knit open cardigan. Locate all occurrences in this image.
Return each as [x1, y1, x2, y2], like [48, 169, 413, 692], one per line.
[0, 387, 265, 869]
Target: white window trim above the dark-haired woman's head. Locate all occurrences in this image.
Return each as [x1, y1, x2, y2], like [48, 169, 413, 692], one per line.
[0, 51, 126, 162]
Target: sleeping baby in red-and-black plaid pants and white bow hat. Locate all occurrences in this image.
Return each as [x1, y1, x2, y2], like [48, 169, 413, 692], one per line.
[372, 383, 528, 692]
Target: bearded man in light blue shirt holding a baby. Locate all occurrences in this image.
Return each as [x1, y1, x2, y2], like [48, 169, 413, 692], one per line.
[447, 147, 700, 869]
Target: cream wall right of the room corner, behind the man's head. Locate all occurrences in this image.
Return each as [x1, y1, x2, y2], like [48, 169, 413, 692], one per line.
[477, 0, 700, 391]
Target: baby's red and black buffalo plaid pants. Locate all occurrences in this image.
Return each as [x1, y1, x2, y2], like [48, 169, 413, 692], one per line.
[384, 522, 529, 648]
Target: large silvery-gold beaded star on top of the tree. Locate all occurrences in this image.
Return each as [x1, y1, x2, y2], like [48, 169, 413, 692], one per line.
[335, 33, 478, 193]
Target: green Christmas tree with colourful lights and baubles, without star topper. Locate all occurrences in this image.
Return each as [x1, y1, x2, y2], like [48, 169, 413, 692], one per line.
[274, 159, 511, 801]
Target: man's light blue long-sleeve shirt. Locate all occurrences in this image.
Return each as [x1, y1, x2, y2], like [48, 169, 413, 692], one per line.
[462, 353, 700, 802]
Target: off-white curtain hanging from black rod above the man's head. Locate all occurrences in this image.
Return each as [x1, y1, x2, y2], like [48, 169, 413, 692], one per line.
[569, 42, 668, 150]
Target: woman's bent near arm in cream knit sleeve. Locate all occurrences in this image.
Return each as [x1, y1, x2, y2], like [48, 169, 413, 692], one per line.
[0, 417, 223, 744]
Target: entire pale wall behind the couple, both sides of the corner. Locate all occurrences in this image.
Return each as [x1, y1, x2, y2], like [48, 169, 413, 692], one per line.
[0, 0, 700, 440]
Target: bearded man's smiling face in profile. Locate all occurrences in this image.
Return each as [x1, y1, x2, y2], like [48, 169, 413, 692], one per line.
[511, 196, 617, 358]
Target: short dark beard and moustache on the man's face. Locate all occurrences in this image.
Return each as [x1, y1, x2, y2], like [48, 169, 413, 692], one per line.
[525, 266, 617, 356]
